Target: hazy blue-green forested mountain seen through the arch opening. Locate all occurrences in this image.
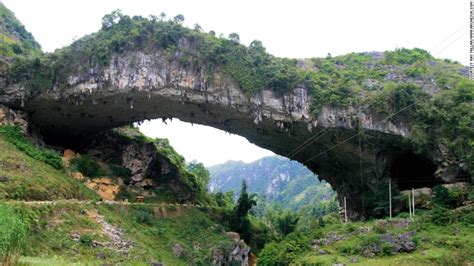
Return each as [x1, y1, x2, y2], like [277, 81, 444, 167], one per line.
[208, 156, 335, 211]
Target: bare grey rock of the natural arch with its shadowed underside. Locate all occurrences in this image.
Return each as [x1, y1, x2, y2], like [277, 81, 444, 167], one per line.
[0, 42, 468, 218]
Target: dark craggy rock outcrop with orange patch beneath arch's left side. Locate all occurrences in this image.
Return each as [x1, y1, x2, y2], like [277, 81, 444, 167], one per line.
[78, 128, 197, 202]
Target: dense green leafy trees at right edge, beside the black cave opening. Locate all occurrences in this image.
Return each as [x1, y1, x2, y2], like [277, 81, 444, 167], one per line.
[411, 78, 474, 177]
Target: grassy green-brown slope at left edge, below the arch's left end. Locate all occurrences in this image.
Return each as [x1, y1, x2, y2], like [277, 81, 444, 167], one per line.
[0, 126, 97, 200]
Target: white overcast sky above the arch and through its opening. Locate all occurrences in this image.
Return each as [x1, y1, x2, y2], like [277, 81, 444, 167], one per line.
[0, 0, 469, 166]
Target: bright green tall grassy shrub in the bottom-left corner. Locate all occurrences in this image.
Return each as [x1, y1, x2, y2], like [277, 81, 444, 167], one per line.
[0, 205, 30, 265]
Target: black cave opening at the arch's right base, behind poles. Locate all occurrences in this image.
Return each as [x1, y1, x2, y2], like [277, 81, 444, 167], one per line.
[391, 153, 438, 190]
